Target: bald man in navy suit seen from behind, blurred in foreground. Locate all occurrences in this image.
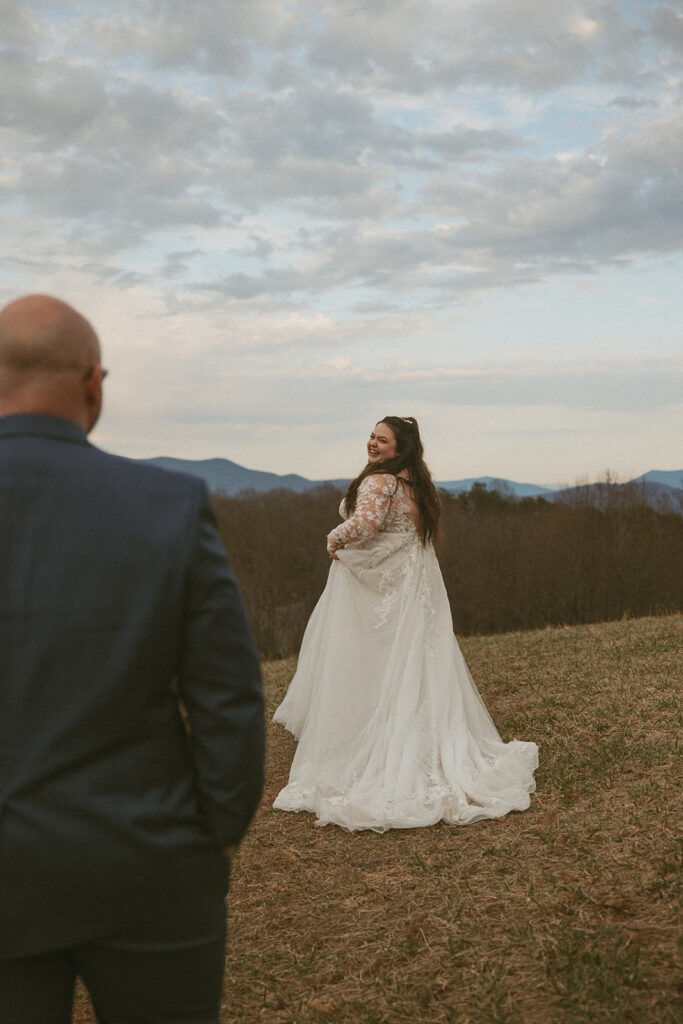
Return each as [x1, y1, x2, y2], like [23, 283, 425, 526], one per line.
[0, 296, 263, 1024]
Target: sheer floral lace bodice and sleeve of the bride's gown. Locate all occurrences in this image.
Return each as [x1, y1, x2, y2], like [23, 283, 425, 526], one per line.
[328, 473, 417, 554]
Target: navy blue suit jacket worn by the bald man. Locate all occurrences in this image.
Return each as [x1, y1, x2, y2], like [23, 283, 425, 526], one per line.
[0, 415, 263, 956]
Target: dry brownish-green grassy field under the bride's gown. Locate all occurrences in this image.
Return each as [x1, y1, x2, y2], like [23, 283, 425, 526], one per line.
[74, 615, 683, 1024]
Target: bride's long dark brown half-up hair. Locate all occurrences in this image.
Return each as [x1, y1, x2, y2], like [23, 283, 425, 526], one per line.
[344, 416, 441, 544]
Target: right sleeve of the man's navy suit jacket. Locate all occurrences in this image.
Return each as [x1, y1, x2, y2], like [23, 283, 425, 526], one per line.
[178, 485, 264, 847]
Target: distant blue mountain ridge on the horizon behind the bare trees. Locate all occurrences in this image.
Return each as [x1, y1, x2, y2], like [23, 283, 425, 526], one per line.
[141, 457, 683, 501]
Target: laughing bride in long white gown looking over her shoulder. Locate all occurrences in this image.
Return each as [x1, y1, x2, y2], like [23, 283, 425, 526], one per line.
[273, 416, 538, 831]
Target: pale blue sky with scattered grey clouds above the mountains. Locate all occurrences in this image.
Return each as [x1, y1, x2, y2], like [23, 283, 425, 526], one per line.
[0, 0, 683, 485]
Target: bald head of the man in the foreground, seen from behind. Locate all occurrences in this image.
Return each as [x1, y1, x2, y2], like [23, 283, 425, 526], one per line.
[0, 295, 102, 432]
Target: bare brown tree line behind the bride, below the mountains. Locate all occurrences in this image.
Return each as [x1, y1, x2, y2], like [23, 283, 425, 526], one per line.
[213, 477, 683, 658]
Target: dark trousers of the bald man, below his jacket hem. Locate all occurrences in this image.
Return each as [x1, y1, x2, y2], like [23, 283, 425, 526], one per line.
[0, 917, 225, 1024]
